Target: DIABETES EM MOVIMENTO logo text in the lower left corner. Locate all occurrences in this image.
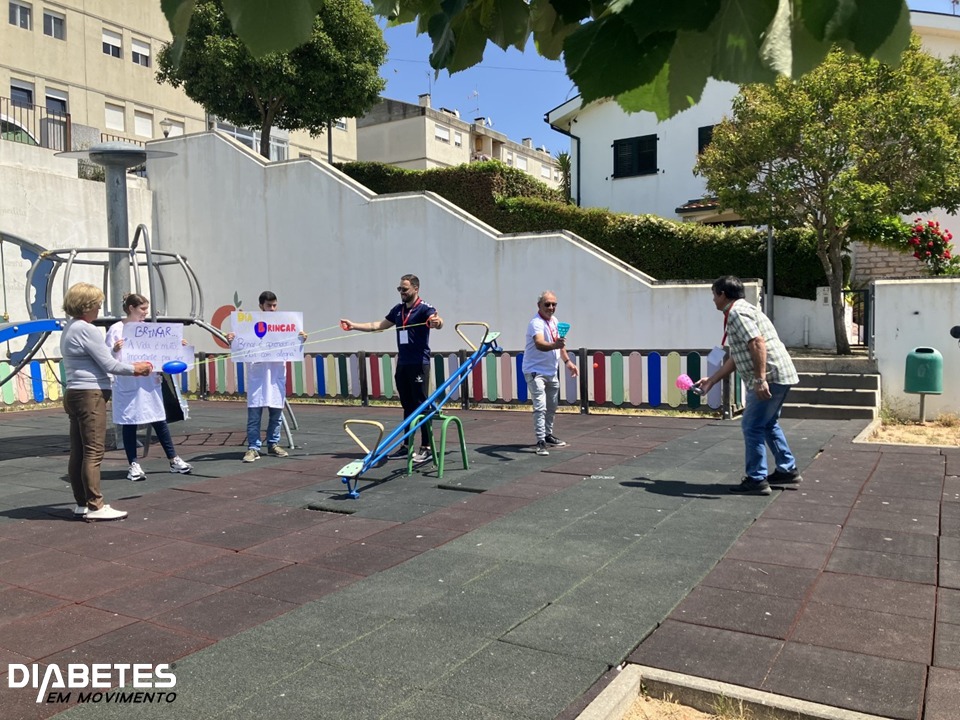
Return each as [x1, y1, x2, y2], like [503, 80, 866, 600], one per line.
[7, 663, 177, 705]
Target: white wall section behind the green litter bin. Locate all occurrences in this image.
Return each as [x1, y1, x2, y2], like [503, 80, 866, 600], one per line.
[874, 279, 960, 419]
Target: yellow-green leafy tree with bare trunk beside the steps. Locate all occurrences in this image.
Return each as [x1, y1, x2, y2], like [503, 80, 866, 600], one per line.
[696, 37, 960, 354]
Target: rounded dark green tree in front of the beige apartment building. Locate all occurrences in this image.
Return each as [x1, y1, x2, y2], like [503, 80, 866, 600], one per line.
[157, 0, 387, 157]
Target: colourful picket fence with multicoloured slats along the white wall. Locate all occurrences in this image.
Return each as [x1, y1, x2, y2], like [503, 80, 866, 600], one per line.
[0, 349, 742, 412]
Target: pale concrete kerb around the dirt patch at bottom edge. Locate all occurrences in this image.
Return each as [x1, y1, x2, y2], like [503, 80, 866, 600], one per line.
[577, 664, 886, 720]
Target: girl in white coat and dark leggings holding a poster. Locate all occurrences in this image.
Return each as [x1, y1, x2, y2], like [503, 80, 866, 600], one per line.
[107, 293, 193, 482]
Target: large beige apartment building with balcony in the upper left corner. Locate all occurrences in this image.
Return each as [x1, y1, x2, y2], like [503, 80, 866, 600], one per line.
[0, 0, 357, 161]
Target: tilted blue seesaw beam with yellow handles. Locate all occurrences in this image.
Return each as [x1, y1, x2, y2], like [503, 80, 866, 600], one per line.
[337, 322, 502, 498]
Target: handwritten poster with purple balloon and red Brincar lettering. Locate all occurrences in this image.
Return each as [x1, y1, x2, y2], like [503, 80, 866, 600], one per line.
[230, 310, 303, 363]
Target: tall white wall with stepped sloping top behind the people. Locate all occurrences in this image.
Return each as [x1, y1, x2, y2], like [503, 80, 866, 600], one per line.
[149, 134, 758, 351]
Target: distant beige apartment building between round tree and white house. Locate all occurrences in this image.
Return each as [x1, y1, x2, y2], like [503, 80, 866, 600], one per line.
[357, 94, 560, 188]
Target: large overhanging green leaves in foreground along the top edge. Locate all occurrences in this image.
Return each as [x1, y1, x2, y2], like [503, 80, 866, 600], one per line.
[161, 0, 910, 119]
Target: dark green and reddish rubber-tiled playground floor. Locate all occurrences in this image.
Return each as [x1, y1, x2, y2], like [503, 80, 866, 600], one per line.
[0, 402, 960, 720]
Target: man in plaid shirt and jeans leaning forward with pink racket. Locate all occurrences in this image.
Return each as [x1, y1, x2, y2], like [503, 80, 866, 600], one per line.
[697, 275, 803, 495]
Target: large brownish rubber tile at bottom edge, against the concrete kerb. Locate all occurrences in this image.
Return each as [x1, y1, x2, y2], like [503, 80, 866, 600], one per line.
[761, 642, 926, 720]
